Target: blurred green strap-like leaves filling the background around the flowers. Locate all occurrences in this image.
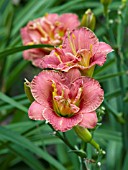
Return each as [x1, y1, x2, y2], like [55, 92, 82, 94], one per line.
[0, 0, 128, 170]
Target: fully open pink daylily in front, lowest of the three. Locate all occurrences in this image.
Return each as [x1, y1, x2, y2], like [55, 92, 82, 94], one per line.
[28, 69, 103, 132]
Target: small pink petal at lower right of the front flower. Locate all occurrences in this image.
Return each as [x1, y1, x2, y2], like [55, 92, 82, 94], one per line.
[79, 112, 98, 129]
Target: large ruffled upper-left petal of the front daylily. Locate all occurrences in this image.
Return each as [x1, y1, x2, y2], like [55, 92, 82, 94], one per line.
[31, 71, 64, 106]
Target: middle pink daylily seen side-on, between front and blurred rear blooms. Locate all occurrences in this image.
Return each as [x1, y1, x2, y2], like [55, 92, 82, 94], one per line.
[41, 27, 113, 76]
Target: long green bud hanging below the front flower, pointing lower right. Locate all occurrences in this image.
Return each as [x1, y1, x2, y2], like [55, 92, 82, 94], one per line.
[74, 126, 100, 151]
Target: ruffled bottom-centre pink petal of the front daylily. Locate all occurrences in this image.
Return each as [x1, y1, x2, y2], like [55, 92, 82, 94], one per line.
[42, 108, 83, 132]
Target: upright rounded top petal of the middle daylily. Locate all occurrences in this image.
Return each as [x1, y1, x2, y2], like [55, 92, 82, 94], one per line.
[62, 27, 99, 54]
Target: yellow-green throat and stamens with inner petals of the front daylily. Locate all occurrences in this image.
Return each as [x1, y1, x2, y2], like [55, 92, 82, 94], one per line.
[52, 81, 82, 117]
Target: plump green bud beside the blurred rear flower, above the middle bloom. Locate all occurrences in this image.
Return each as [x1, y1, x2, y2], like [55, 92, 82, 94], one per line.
[81, 9, 96, 30]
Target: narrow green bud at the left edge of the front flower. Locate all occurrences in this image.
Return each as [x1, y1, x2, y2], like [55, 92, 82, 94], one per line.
[24, 79, 34, 102]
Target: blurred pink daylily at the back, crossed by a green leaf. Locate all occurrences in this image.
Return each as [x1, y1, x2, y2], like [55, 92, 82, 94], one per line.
[21, 13, 80, 67]
